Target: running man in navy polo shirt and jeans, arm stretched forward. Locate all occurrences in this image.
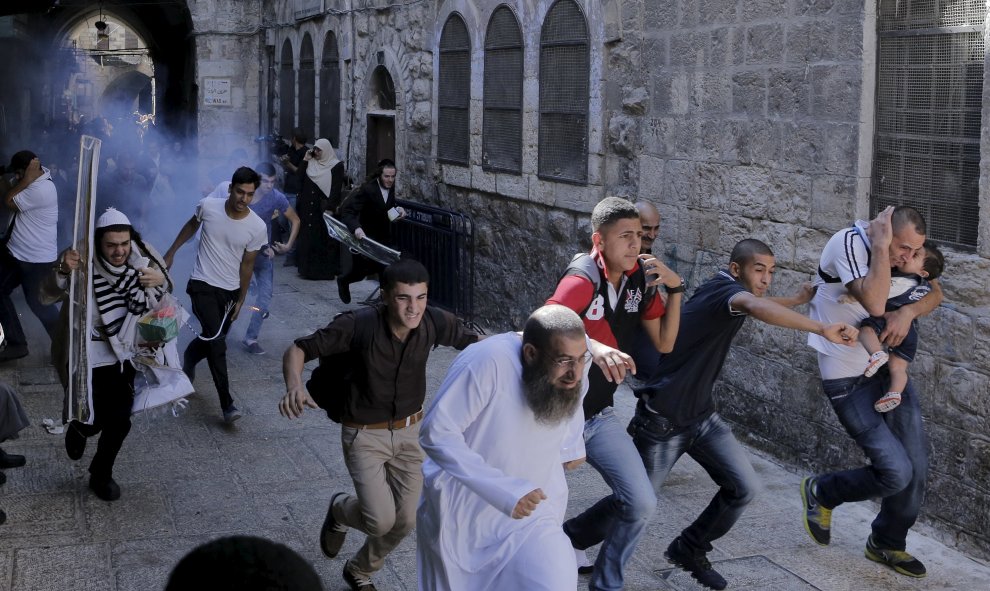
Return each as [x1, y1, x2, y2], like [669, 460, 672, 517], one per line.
[629, 239, 858, 589]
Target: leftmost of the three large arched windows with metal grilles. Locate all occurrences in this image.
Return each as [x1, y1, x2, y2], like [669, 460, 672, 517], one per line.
[437, 14, 471, 166]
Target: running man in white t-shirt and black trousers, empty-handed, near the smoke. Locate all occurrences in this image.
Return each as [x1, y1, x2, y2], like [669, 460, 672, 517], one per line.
[165, 166, 268, 424]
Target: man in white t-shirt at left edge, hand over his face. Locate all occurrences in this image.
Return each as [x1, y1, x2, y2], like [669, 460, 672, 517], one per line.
[0, 150, 58, 362]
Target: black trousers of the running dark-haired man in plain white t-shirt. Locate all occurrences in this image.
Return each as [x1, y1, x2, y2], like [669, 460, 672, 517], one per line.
[182, 279, 239, 410]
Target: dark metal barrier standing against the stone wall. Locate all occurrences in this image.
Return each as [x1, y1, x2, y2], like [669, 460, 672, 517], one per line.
[392, 199, 474, 321]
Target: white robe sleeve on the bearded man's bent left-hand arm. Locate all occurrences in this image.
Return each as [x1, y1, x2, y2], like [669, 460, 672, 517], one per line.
[419, 348, 538, 516]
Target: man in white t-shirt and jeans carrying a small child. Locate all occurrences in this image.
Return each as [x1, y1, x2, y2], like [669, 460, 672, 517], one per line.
[801, 206, 942, 577]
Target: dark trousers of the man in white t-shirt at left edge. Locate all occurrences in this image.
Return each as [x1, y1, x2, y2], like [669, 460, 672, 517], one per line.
[0, 258, 58, 347]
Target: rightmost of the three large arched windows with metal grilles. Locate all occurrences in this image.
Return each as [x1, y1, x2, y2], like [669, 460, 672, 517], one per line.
[539, 0, 590, 183]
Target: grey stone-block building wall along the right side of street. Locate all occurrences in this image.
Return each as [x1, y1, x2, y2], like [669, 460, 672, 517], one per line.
[264, 0, 990, 556]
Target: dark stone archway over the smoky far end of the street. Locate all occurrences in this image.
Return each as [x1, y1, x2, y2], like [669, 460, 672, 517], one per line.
[0, 0, 197, 161]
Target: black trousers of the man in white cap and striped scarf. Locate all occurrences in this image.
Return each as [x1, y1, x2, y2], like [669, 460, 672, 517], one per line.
[69, 363, 136, 479]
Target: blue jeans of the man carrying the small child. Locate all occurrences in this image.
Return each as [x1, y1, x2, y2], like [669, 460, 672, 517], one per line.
[815, 373, 928, 550]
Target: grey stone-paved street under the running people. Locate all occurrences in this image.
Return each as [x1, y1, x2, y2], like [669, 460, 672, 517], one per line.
[0, 264, 990, 591]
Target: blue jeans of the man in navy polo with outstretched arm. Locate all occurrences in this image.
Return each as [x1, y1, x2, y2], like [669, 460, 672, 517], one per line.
[629, 403, 762, 553]
